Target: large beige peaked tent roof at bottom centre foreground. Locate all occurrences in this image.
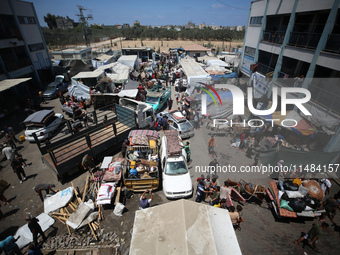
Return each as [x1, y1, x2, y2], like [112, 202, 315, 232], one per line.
[130, 199, 242, 255]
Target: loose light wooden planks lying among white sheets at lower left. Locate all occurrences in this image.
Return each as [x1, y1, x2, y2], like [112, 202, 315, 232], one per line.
[52, 182, 101, 241]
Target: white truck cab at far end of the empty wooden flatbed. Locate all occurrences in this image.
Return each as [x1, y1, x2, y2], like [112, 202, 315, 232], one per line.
[119, 98, 155, 128]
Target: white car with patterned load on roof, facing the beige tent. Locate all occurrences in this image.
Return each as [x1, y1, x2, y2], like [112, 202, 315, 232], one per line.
[160, 130, 193, 199]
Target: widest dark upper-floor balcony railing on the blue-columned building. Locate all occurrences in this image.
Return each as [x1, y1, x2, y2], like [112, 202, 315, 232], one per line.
[288, 32, 321, 49]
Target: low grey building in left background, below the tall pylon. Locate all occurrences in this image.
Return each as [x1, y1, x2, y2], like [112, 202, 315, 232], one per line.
[52, 47, 92, 63]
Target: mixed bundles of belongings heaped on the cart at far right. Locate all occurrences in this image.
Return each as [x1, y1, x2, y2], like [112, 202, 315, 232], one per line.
[277, 179, 325, 213]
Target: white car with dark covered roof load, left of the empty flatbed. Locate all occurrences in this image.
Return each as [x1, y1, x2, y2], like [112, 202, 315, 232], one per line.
[23, 110, 64, 142]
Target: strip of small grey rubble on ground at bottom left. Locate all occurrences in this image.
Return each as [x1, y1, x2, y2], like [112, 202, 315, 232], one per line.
[42, 229, 124, 250]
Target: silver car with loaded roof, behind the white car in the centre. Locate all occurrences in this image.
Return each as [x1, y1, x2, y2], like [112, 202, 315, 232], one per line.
[157, 110, 194, 139]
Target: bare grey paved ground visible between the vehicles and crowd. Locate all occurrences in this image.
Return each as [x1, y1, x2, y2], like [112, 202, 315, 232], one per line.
[0, 87, 340, 255]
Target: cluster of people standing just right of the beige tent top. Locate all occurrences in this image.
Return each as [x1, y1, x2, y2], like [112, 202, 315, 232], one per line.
[195, 175, 244, 230]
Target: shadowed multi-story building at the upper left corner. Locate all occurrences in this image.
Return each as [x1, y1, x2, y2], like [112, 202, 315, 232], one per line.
[0, 0, 53, 84]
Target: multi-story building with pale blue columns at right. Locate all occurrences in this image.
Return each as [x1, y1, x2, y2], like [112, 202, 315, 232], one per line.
[239, 0, 340, 151]
